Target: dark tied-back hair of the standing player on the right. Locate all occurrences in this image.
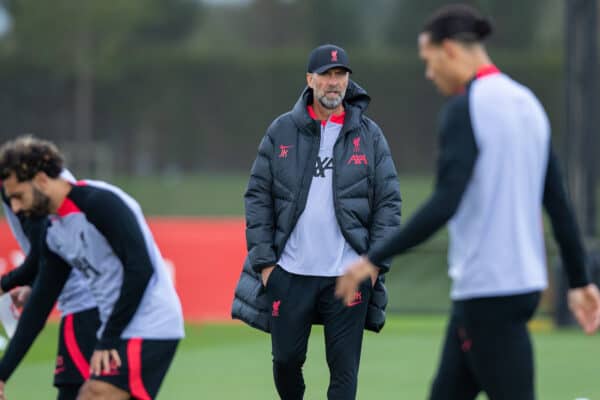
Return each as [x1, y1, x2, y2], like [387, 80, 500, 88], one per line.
[423, 4, 493, 43]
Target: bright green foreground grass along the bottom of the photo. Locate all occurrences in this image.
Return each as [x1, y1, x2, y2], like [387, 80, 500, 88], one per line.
[2, 316, 600, 400]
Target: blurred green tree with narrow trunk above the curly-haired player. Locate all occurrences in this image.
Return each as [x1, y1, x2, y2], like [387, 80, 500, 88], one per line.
[4, 0, 199, 172]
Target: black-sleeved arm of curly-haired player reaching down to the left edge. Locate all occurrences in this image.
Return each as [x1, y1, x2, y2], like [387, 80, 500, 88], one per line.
[0, 249, 71, 382]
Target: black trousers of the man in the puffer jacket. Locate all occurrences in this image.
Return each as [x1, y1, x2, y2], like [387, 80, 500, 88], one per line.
[266, 266, 372, 400]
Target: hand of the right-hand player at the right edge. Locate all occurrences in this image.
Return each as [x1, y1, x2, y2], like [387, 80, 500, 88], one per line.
[568, 283, 600, 335]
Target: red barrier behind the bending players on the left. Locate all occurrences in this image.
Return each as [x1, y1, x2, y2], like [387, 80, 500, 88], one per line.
[0, 218, 246, 321]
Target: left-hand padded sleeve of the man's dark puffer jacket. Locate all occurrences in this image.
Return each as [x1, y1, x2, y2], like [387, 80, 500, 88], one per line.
[244, 130, 277, 272]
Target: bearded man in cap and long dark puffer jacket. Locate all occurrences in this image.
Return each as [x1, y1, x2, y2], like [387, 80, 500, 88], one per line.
[233, 45, 400, 400]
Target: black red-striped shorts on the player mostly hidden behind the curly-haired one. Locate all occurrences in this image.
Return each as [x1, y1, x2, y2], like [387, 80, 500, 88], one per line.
[54, 308, 100, 387]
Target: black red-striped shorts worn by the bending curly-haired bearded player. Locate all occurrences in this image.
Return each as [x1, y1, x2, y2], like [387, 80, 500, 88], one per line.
[91, 338, 179, 400]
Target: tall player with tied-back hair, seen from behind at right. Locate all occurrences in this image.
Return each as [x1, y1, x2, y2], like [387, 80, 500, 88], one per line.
[337, 5, 600, 400]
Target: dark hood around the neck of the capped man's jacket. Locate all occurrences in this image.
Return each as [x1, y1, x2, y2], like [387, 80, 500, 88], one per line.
[292, 80, 371, 128]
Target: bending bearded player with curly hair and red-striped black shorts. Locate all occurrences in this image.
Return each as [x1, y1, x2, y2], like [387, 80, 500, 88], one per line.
[0, 136, 184, 400]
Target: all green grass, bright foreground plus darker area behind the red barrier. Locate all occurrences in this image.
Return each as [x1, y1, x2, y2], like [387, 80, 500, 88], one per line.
[7, 174, 600, 400]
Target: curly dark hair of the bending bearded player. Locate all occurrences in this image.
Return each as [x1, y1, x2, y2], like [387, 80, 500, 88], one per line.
[0, 135, 64, 182]
